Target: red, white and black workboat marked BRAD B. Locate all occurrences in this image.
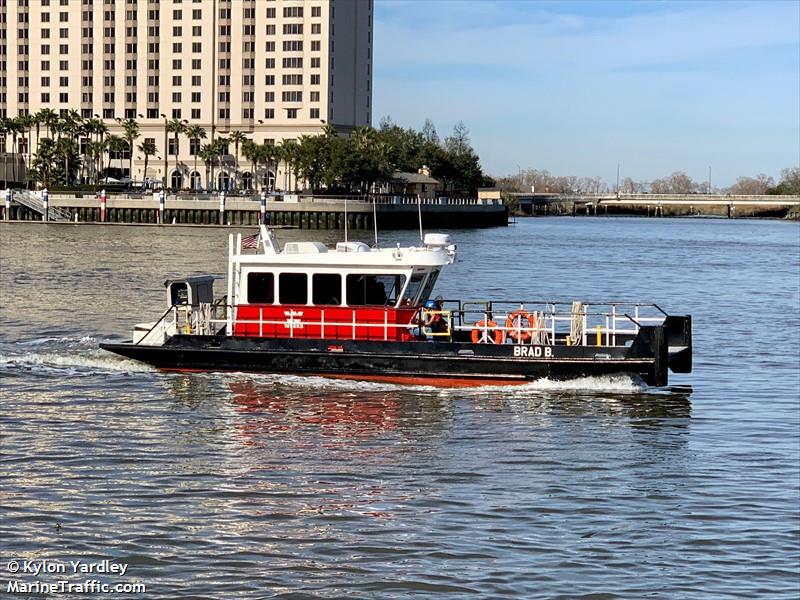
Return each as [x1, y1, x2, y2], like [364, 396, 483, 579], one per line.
[100, 225, 692, 387]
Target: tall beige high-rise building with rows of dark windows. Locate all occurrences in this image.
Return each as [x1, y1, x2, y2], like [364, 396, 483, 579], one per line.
[0, 0, 373, 188]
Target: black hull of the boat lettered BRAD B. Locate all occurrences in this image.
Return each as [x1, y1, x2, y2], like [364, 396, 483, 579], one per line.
[95, 327, 677, 386]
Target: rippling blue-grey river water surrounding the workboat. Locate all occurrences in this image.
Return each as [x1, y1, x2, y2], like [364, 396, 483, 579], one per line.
[0, 217, 800, 599]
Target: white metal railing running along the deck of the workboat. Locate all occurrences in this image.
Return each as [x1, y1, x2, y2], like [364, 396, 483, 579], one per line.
[153, 302, 666, 347]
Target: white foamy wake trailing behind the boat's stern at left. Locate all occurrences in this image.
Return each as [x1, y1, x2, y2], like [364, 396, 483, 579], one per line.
[0, 336, 154, 377]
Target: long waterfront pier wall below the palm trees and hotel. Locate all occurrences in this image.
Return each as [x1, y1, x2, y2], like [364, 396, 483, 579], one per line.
[2, 190, 508, 229]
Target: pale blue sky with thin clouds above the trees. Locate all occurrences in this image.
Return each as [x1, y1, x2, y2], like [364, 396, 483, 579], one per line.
[373, 0, 800, 187]
